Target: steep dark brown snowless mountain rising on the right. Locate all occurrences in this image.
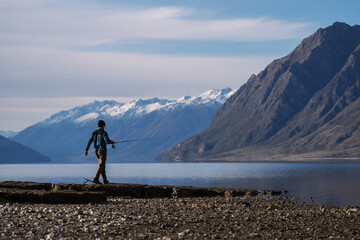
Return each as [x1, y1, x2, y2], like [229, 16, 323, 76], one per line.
[165, 22, 360, 161]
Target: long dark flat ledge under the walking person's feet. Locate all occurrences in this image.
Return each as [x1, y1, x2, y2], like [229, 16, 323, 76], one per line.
[0, 181, 286, 204]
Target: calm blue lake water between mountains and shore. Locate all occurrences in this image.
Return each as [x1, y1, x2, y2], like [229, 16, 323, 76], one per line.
[0, 163, 360, 206]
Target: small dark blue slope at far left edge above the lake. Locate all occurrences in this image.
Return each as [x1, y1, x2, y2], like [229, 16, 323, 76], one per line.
[0, 135, 50, 163]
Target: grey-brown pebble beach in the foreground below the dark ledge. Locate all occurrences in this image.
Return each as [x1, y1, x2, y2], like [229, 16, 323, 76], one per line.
[0, 182, 360, 239]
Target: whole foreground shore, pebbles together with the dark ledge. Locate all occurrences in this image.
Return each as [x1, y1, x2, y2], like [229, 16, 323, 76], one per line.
[0, 182, 360, 240]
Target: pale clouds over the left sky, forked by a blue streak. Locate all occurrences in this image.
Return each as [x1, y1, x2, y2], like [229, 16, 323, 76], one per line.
[0, 0, 308, 130]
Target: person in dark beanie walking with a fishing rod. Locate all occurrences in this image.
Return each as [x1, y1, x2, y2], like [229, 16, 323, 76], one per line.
[84, 120, 115, 184]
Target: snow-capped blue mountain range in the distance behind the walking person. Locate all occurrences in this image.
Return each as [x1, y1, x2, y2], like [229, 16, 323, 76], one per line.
[14, 88, 234, 162]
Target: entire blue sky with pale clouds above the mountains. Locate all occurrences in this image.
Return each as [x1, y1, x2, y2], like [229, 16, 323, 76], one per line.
[0, 0, 360, 131]
